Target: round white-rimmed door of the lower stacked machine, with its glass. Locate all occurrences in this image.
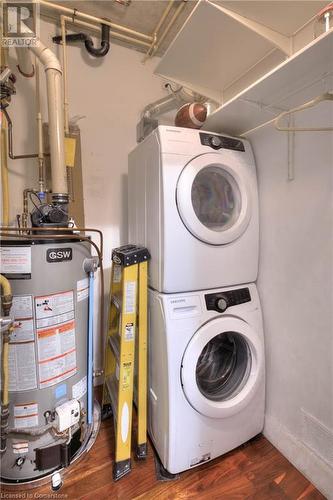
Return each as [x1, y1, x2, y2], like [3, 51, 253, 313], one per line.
[181, 316, 264, 418]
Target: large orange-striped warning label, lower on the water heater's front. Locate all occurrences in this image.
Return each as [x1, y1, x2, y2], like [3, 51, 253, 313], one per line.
[37, 321, 77, 389]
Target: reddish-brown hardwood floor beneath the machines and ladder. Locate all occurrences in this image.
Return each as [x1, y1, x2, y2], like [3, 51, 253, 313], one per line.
[13, 406, 325, 500]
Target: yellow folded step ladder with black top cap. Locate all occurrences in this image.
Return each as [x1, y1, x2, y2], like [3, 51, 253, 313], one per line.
[103, 245, 150, 481]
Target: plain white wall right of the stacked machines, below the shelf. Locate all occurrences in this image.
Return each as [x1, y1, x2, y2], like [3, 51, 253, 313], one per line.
[250, 103, 333, 498]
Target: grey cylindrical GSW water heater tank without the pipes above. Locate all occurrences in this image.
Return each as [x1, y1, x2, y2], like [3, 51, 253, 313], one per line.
[1, 234, 96, 484]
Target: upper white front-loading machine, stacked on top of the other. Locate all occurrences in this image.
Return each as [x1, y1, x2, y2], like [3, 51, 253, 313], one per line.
[129, 126, 259, 293]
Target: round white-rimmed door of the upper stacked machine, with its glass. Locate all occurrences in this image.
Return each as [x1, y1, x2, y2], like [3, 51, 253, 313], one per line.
[176, 153, 251, 245]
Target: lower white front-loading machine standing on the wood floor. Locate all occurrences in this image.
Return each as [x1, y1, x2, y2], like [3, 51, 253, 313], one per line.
[149, 284, 265, 474]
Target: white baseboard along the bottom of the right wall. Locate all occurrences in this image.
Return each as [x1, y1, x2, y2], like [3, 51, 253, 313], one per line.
[264, 416, 333, 500]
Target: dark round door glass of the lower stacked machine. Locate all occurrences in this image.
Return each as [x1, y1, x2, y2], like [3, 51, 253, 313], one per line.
[196, 332, 251, 401]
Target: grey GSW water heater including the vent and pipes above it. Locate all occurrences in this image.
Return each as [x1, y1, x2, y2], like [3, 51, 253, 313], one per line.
[0, 14, 103, 489]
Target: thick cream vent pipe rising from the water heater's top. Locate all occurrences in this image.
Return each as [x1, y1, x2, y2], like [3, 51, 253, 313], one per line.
[20, 26, 68, 204]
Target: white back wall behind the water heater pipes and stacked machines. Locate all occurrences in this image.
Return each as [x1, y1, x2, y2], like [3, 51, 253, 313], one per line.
[3, 17, 165, 374]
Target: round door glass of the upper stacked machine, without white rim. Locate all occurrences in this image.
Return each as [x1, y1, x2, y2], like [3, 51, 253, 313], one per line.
[191, 165, 241, 231]
